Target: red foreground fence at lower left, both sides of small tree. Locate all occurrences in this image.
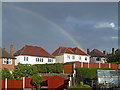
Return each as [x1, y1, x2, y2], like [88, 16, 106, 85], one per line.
[0, 75, 68, 90]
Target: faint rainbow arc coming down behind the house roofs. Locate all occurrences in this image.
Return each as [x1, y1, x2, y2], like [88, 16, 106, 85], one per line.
[2, 3, 83, 50]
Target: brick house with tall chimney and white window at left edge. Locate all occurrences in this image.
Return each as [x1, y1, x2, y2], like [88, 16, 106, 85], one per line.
[0, 45, 15, 73]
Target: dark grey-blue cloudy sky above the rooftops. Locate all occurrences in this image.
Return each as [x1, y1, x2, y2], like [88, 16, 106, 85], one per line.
[2, 2, 118, 53]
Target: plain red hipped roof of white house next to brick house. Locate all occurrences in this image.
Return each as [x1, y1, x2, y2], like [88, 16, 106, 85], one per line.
[14, 45, 54, 58]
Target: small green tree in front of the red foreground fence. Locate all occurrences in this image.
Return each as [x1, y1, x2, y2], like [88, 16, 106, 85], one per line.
[32, 74, 44, 90]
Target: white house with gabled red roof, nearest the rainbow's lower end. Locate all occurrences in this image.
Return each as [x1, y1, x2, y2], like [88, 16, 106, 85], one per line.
[52, 47, 90, 63]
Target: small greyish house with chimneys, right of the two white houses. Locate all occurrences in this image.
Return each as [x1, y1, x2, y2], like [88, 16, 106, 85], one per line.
[87, 49, 106, 63]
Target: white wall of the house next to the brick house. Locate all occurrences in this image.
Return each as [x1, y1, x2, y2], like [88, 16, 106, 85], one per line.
[15, 55, 56, 66]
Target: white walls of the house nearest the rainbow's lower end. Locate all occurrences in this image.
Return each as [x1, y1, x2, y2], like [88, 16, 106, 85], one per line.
[55, 53, 90, 63]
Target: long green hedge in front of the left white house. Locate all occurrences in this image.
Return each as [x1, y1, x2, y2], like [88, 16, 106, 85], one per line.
[13, 63, 63, 79]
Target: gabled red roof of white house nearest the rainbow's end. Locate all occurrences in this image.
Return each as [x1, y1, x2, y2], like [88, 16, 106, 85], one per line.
[52, 47, 89, 56]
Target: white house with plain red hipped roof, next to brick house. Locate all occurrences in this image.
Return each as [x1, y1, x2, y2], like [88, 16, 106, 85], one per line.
[14, 45, 56, 66]
